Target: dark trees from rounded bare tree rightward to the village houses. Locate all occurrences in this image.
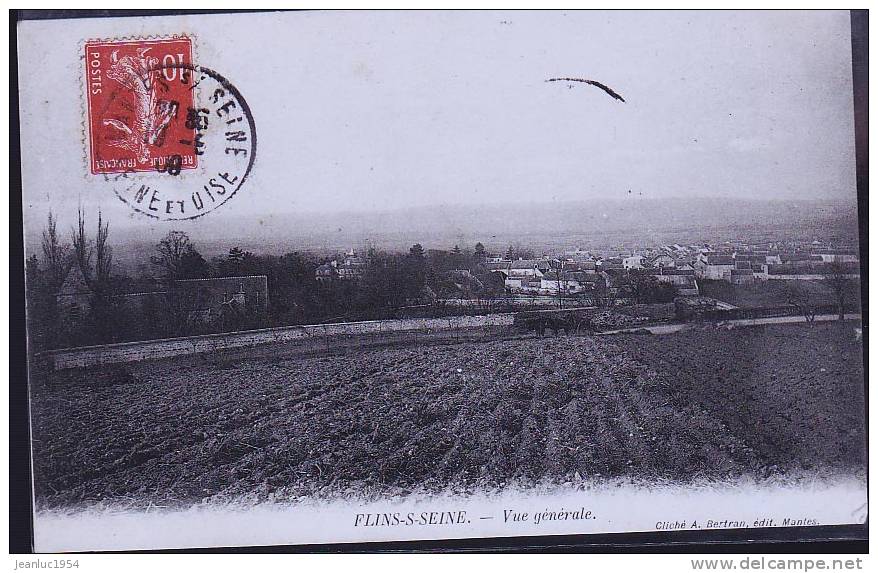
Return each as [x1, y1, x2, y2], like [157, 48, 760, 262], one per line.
[153, 238, 503, 325]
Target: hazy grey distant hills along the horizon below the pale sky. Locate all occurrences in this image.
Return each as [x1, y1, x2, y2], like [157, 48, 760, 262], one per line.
[29, 196, 857, 272]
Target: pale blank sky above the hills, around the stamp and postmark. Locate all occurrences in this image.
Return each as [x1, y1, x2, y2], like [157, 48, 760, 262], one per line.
[19, 7, 856, 239]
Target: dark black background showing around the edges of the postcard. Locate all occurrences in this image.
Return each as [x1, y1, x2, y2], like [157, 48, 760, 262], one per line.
[9, 10, 869, 553]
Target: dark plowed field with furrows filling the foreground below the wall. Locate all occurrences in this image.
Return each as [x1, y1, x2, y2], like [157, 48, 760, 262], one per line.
[32, 324, 865, 507]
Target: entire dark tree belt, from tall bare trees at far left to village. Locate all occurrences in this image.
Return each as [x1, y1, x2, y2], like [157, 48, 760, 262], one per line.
[27, 210, 696, 348]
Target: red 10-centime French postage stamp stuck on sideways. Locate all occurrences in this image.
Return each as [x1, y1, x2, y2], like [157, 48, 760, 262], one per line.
[85, 37, 198, 175]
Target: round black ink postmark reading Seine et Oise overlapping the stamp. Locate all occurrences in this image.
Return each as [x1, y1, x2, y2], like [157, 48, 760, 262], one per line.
[104, 62, 256, 221]
